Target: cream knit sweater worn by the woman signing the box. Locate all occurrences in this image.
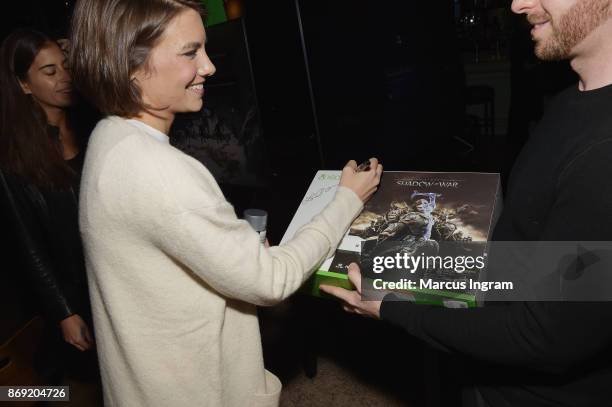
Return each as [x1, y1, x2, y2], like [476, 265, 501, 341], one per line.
[80, 117, 362, 407]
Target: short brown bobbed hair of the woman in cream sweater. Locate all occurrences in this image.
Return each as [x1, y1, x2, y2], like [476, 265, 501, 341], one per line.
[70, 0, 203, 117]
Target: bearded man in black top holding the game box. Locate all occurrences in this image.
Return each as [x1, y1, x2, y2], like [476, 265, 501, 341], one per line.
[323, 0, 612, 407]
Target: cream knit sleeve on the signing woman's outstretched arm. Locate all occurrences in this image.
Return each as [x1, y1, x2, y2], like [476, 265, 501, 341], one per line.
[155, 187, 362, 305]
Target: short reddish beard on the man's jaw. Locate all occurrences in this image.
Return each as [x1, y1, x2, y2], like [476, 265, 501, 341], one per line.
[527, 0, 610, 61]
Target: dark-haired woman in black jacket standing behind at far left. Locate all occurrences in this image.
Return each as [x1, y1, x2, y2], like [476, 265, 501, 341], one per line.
[0, 29, 94, 384]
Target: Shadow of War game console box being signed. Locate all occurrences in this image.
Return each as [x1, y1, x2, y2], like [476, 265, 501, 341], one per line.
[281, 170, 501, 308]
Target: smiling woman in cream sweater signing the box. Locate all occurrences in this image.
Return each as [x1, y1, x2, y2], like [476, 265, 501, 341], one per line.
[70, 0, 382, 407]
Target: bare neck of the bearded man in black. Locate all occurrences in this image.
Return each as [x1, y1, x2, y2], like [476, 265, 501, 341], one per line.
[570, 20, 612, 91]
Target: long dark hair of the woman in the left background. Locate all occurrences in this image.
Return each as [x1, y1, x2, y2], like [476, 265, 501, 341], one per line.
[0, 29, 75, 188]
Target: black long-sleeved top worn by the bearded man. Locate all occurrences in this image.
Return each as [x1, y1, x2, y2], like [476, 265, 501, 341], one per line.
[381, 85, 612, 407]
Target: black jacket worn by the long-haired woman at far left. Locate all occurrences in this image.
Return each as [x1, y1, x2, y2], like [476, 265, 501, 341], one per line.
[0, 159, 89, 322]
